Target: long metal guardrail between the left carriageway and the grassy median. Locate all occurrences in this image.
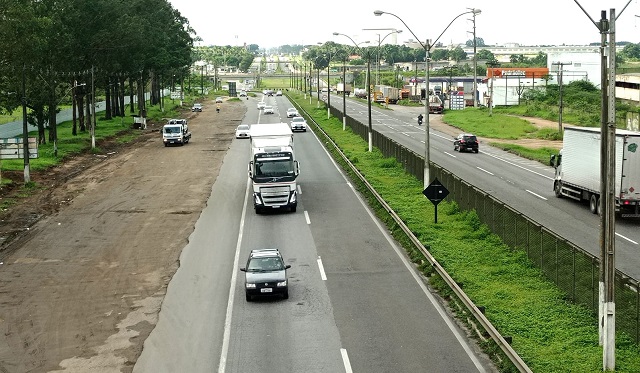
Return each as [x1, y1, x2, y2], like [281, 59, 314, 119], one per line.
[294, 102, 533, 372]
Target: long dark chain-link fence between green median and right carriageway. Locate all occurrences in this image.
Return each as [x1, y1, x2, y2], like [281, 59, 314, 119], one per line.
[331, 103, 640, 343]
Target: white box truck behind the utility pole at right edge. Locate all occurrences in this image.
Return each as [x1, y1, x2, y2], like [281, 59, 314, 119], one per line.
[551, 127, 640, 217]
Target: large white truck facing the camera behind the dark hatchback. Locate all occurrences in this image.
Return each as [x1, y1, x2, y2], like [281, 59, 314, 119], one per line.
[249, 123, 300, 214]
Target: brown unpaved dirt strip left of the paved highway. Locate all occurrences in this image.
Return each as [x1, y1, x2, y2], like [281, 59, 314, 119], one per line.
[0, 102, 246, 372]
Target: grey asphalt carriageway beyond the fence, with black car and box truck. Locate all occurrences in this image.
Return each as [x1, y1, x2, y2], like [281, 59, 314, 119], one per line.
[324, 96, 640, 279]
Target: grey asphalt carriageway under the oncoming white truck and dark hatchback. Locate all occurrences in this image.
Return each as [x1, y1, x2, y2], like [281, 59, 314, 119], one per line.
[133, 97, 496, 373]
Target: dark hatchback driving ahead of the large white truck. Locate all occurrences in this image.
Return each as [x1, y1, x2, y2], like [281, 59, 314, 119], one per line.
[240, 249, 291, 302]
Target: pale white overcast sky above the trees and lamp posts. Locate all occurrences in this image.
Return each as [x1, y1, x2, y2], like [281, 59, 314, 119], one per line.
[169, 0, 640, 48]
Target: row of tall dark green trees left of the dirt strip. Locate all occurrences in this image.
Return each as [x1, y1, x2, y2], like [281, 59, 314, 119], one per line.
[0, 0, 195, 147]
